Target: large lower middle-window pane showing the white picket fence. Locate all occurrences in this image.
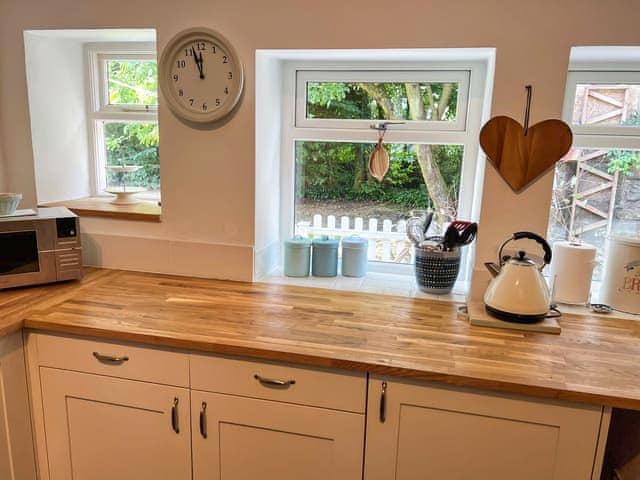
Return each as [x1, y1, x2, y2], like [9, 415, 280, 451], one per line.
[295, 141, 463, 263]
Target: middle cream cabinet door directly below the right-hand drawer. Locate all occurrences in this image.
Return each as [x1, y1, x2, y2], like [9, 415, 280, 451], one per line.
[191, 390, 364, 480]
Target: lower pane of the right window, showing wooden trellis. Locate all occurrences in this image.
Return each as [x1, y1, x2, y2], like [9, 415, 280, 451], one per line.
[548, 149, 640, 280]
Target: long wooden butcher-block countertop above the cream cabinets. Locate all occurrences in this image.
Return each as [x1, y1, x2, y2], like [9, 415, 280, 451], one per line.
[0, 270, 640, 410]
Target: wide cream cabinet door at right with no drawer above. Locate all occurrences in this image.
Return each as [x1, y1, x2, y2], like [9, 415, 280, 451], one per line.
[364, 377, 602, 480]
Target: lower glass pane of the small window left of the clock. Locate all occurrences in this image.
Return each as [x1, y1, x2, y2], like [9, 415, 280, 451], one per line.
[103, 122, 160, 193]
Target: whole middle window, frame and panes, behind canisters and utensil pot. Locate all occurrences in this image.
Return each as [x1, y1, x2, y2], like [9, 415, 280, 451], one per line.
[281, 61, 485, 279]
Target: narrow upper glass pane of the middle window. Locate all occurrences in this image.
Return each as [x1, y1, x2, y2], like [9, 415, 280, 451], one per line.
[306, 82, 460, 122]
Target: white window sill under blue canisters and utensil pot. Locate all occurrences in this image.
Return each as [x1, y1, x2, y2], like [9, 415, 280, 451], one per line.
[258, 271, 469, 303]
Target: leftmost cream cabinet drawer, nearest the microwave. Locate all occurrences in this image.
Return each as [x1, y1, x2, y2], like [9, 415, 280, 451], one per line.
[29, 333, 189, 387]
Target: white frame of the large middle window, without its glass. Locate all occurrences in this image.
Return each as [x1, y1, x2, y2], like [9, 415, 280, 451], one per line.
[280, 60, 487, 277]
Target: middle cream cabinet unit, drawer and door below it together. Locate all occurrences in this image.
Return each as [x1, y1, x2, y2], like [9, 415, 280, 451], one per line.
[190, 354, 366, 480]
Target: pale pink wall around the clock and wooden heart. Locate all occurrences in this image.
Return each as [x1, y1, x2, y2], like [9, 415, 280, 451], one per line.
[0, 0, 640, 289]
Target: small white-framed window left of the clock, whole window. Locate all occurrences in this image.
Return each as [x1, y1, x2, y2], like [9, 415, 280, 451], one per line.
[87, 42, 160, 200]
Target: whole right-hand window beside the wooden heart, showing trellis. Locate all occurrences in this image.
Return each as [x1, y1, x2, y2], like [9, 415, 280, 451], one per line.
[548, 70, 640, 282]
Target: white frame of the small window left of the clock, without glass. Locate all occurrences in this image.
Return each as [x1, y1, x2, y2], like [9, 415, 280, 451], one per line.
[85, 42, 160, 196]
